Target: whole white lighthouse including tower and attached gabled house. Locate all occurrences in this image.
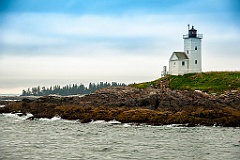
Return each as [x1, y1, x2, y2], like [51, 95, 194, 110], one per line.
[169, 26, 203, 75]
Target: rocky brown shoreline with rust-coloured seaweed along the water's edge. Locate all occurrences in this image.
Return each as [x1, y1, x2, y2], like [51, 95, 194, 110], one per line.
[0, 87, 240, 127]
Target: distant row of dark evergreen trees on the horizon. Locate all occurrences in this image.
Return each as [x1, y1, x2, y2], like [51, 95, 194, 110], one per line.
[21, 82, 126, 96]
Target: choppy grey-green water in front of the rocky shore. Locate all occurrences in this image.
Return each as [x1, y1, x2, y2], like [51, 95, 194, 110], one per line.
[0, 114, 240, 160]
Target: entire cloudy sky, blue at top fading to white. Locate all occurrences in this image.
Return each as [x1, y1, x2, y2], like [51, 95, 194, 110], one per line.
[0, 0, 240, 94]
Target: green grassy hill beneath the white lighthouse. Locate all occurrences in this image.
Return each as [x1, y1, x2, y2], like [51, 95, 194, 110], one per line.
[130, 72, 240, 94]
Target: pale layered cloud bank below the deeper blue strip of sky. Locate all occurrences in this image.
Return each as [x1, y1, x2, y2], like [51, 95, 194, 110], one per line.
[0, 6, 240, 93]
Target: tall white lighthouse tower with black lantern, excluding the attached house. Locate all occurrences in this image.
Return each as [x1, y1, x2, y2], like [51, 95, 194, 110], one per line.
[183, 26, 202, 73]
